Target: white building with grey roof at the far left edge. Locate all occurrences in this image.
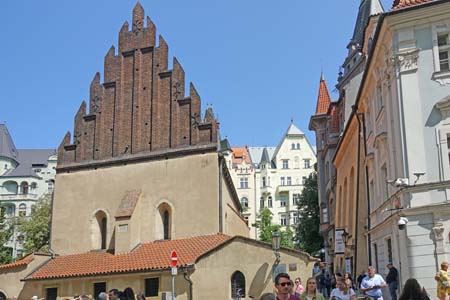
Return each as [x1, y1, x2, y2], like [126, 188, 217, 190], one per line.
[0, 124, 57, 257]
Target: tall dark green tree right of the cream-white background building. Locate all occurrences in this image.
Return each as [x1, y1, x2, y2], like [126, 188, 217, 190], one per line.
[294, 172, 323, 254]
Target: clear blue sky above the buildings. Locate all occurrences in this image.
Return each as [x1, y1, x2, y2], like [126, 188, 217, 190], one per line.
[0, 0, 392, 148]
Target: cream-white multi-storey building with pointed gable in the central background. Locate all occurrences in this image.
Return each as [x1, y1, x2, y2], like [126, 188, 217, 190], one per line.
[228, 123, 316, 238]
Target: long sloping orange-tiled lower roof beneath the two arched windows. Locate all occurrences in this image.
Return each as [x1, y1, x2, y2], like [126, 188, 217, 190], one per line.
[25, 234, 231, 280]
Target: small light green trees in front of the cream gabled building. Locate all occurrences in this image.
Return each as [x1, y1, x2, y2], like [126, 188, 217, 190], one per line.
[252, 208, 293, 248]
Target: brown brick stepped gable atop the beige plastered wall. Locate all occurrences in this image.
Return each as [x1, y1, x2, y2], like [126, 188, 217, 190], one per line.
[58, 3, 218, 168]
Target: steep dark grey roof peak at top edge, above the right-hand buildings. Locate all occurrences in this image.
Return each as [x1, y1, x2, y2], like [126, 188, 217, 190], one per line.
[350, 0, 384, 47]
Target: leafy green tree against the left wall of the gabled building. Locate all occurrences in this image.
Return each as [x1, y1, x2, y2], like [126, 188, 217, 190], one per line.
[19, 194, 52, 253]
